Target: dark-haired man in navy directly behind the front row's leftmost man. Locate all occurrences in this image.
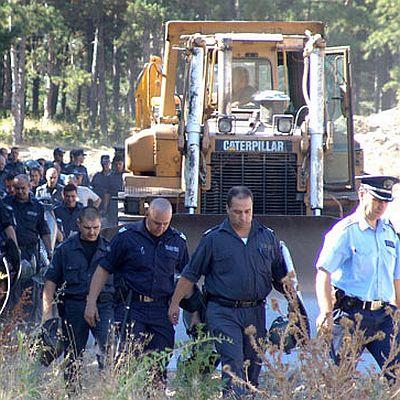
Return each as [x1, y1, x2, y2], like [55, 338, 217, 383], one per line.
[54, 183, 83, 239]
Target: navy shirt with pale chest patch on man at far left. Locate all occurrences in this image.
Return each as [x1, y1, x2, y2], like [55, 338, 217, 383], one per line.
[4, 195, 50, 248]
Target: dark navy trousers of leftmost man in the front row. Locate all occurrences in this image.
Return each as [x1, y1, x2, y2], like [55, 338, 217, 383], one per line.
[58, 299, 114, 385]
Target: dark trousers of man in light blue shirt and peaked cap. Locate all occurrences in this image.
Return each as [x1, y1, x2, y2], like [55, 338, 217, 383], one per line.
[331, 305, 400, 380]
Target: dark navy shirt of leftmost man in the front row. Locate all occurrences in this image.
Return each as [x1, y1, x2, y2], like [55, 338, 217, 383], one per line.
[45, 233, 114, 296]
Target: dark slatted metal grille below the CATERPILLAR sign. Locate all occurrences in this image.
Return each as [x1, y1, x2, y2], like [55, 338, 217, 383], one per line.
[201, 152, 305, 215]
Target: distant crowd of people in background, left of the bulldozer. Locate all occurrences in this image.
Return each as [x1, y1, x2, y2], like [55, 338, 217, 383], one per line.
[0, 147, 125, 228]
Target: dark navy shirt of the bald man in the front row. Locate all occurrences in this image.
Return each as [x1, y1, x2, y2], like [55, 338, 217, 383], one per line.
[100, 220, 188, 299]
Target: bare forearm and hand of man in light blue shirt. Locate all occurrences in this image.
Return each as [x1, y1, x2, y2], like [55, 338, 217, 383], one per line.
[315, 268, 333, 331]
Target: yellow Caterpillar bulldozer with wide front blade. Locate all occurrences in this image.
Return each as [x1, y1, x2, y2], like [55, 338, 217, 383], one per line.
[120, 21, 363, 286]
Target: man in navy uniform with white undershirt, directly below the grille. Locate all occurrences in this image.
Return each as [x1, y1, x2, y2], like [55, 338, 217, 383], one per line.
[168, 186, 286, 396]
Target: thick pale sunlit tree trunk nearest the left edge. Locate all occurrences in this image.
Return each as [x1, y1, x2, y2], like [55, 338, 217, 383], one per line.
[11, 37, 26, 144]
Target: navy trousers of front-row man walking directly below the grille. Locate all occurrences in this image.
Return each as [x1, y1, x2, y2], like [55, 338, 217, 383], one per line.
[206, 301, 266, 397]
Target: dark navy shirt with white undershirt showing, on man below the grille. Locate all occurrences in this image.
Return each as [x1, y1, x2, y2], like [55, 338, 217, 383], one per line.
[182, 219, 286, 301]
